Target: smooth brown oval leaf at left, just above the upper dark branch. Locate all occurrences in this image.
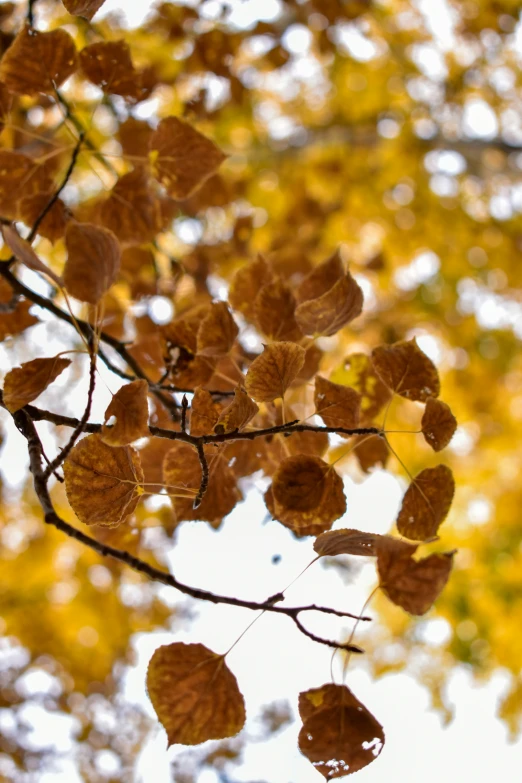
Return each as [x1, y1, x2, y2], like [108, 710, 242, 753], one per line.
[63, 220, 121, 304]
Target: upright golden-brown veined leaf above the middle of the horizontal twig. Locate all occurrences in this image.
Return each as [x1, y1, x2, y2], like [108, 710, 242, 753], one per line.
[245, 342, 305, 402]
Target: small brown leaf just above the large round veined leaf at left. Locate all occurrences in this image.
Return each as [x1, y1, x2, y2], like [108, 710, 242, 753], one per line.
[101, 380, 150, 446]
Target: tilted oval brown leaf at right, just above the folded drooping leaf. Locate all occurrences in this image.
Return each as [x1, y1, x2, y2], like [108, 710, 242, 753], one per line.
[397, 465, 455, 541]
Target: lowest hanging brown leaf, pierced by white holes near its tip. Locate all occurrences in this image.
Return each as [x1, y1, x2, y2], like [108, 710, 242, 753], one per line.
[299, 685, 384, 780]
